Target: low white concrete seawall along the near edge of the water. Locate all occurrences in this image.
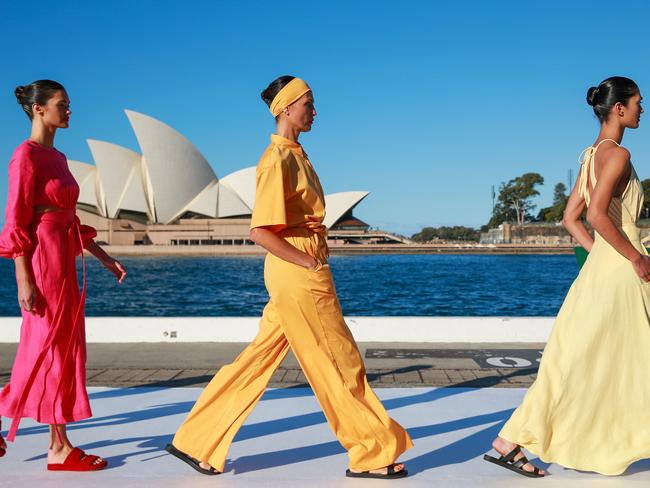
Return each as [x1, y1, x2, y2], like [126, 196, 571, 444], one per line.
[0, 317, 554, 344]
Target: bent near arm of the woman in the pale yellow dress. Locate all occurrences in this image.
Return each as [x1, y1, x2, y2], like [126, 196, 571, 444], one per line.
[587, 148, 650, 281]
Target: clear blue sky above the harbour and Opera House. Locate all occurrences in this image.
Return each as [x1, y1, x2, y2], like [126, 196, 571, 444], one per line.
[0, 0, 650, 234]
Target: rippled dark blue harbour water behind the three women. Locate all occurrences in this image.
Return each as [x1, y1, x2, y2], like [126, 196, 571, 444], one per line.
[0, 255, 578, 317]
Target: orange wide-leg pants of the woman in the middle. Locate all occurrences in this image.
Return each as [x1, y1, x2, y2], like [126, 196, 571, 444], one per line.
[173, 232, 413, 471]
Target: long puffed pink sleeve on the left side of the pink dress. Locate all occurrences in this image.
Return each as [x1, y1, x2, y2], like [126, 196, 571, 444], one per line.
[0, 152, 35, 259]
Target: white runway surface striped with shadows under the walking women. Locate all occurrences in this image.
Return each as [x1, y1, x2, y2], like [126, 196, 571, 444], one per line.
[0, 388, 650, 488]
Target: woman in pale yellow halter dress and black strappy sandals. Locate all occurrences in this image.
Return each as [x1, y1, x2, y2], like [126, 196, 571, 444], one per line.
[485, 77, 650, 477]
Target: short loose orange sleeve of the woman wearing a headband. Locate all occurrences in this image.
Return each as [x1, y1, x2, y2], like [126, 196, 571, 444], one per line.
[251, 159, 287, 232]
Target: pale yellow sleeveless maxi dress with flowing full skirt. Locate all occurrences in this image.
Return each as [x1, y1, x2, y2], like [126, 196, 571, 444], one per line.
[499, 141, 650, 475]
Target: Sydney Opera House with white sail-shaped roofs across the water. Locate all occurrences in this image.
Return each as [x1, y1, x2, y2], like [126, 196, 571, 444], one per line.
[69, 110, 398, 246]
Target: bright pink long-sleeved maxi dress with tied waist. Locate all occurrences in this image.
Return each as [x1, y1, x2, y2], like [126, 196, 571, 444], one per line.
[0, 141, 97, 441]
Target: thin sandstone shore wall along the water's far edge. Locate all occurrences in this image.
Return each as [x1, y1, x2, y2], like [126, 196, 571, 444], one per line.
[96, 244, 573, 256]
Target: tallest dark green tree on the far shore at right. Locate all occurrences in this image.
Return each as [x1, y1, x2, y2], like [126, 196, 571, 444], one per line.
[488, 173, 544, 227]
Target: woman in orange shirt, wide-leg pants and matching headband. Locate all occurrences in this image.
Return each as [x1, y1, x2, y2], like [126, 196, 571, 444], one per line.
[167, 76, 413, 479]
